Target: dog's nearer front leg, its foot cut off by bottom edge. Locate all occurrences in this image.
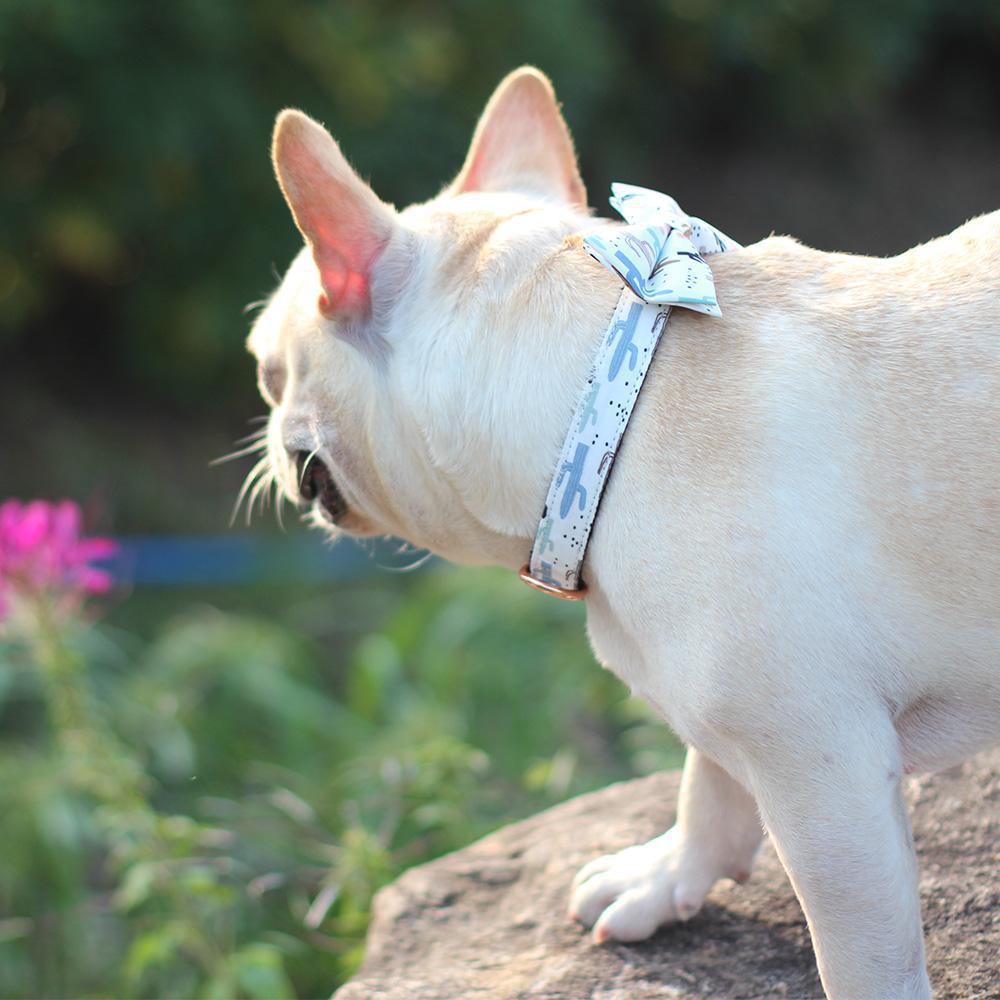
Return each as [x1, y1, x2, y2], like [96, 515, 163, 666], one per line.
[734, 712, 931, 1000]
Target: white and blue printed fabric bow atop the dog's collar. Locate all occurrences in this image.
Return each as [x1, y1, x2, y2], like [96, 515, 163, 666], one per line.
[583, 184, 740, 316]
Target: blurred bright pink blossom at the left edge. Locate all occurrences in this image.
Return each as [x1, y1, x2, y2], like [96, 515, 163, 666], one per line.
[0, 500, 117, 621]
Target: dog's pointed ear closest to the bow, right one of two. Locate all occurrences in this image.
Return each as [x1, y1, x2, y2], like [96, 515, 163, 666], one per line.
[450, 66, 587, 205]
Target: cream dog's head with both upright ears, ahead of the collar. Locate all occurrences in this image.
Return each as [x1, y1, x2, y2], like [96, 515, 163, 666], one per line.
[249, 69, 616, 561]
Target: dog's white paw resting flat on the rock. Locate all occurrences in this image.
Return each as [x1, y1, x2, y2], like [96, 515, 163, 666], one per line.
[569, 828, 726, 944]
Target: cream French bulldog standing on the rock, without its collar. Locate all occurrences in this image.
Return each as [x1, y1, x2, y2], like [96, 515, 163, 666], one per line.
[250, 69, 1000, 1000]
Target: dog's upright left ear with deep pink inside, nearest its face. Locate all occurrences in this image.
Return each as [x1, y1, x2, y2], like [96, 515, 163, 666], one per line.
[271, 110, 396, 319]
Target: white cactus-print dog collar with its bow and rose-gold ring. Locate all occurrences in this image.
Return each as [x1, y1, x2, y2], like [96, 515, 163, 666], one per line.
[520, 184, 739, 600]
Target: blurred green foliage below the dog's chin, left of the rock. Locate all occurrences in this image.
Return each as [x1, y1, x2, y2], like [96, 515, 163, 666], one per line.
[0, 569, 680, 998]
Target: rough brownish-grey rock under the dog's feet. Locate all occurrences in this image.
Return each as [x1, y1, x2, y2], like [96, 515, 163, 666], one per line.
[335, 748, 1000, 1000]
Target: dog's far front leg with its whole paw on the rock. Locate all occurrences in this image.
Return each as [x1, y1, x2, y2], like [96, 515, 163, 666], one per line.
[570, 747, 761, 942]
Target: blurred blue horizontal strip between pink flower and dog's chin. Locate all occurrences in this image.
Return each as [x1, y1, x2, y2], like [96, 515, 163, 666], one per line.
[105, 535, 427, 587]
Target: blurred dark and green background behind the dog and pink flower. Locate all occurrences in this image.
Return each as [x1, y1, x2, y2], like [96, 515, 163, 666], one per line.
[0, 0, 1000, 997]
